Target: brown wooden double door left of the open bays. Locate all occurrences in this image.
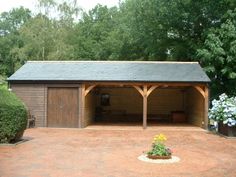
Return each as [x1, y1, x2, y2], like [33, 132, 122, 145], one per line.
[47, 88, 78, 128]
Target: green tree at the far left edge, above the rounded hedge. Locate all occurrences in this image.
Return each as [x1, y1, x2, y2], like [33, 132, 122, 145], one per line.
[0, 7, 31, 76]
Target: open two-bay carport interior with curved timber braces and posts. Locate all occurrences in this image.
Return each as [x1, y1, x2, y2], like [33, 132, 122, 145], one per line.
[83, 83, 208, 128]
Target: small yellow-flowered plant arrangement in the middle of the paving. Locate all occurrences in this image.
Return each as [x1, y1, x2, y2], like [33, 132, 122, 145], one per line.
[147, 134, 172, 159]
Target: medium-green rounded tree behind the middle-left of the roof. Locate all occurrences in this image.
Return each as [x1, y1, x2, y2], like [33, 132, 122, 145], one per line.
[74, 5, 122, 60]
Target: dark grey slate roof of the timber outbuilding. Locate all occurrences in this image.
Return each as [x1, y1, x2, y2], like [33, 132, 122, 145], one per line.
[8, 61, 210, 82]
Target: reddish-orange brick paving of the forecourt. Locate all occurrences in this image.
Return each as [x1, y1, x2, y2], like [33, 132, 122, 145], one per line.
[0, 125, 236, 177]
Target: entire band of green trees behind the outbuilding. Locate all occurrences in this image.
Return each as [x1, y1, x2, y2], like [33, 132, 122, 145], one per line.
[0, 0, 236, 96]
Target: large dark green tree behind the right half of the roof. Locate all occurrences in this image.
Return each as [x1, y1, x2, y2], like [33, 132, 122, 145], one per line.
[121, 0, 235, 61]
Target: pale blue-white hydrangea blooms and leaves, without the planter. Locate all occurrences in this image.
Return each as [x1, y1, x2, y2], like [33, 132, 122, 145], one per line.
[209, 93, 236, 127]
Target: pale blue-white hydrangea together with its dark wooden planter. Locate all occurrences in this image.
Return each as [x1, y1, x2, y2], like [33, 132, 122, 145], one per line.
[209, 93, 236, 137]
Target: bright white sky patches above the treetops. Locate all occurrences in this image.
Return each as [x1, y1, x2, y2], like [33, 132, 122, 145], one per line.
[0, 0, 119, 13]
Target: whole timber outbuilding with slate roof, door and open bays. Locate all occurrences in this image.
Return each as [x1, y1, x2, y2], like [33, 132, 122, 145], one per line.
[8, 61, 210, 128]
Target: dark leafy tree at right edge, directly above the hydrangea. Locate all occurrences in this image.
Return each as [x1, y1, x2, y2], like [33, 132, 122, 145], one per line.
[197, 9, 236, 96]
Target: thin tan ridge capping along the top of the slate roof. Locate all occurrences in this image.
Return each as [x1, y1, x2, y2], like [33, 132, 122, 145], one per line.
[27, 60, 198, 64]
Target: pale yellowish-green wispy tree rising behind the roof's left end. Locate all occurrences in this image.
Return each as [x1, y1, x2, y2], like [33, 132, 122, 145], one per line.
[17, 0, 80, 60]
